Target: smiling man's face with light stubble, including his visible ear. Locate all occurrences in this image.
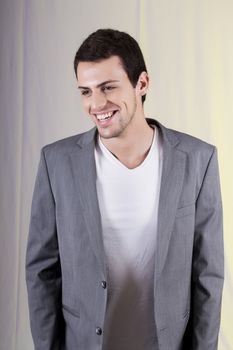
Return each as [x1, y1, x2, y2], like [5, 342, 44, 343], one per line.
[77, 56, 146, 139]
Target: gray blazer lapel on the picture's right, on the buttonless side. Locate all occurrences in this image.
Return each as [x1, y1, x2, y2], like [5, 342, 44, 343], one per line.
[155, 124, 186, 278]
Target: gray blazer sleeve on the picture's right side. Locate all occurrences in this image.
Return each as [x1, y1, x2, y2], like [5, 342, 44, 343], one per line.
[187, 148, 224, 350]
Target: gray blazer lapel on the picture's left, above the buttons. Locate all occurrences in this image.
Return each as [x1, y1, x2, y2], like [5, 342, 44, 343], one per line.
[68, 128, 106, 275]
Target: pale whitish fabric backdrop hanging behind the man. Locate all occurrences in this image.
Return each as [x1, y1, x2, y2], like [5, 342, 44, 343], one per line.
[0, 0, 233, 350]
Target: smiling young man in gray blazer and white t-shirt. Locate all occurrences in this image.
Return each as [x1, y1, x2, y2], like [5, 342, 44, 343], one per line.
[26, 29, 223, 350]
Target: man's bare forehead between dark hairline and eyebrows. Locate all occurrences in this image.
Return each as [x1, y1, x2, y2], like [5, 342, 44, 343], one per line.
[77, 56, 128, 86]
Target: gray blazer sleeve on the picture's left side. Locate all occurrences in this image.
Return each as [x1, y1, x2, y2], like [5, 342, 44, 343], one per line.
[26, 150, 64, 350]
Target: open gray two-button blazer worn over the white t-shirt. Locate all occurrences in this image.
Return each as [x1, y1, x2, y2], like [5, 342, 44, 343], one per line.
[26, 120, 223, 350]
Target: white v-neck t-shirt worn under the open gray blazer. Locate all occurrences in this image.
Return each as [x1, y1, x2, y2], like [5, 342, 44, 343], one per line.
[95, 128, 162, 350]
